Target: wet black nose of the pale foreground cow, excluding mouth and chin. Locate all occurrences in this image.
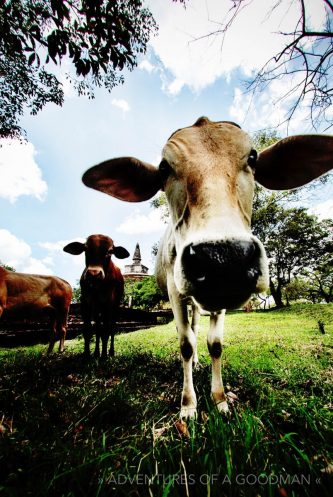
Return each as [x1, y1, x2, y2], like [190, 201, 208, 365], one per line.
[182, 240, 260, 291]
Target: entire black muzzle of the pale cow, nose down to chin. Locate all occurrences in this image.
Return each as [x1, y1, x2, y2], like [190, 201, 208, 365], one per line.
[182, 240, 261, 311]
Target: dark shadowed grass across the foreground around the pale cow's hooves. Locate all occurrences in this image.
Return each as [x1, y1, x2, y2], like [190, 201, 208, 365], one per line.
[0, 352, 330, 497]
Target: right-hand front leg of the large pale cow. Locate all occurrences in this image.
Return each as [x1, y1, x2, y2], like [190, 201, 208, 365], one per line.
[207, 311, 229, 413]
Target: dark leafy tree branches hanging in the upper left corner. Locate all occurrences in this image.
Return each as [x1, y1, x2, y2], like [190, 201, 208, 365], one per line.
[0, 0, 157, 137]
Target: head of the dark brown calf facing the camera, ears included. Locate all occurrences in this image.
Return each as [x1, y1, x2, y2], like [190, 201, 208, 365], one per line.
[63, 235, 129, 282]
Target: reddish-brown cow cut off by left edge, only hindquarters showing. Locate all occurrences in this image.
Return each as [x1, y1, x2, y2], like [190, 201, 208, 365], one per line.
[0, 267, 72, 354]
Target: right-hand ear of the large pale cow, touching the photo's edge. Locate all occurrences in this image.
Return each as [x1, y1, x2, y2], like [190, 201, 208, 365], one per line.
[255, 135, 333, 190]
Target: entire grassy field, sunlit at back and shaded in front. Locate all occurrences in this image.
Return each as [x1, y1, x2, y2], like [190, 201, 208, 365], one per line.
[0, 305, 333, 497]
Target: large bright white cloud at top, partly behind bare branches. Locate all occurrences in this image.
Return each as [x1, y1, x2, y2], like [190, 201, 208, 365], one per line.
[148, 0, 324, 92]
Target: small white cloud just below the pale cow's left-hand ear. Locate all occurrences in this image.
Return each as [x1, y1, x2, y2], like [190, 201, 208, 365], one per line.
[116, 209, 165, 235]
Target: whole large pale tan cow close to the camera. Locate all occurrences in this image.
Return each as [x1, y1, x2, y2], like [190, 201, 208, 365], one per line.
[82, 117, 333, 418]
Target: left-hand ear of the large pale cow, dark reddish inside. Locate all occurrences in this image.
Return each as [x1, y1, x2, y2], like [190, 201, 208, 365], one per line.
[82, 157, 162, 202]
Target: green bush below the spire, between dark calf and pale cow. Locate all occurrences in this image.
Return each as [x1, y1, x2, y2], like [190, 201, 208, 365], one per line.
[125, 276, 166, 310]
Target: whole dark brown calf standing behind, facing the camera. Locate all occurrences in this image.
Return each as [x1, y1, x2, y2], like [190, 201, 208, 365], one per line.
[63, 235, 129, 358]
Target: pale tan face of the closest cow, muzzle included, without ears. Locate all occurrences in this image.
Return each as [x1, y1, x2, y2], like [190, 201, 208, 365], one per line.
[160, 119, 268, 311]
